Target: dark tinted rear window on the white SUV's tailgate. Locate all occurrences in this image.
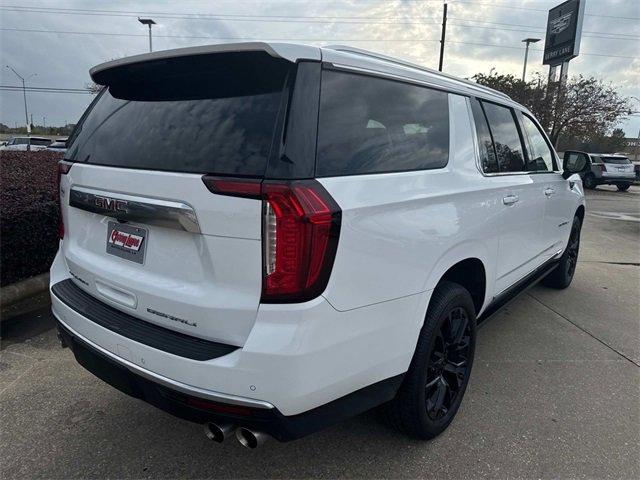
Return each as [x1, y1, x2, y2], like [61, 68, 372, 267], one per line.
[65, 52, 289, 176]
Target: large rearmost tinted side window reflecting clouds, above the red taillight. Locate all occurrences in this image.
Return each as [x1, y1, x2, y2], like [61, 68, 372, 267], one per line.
[316, 70, 449, 176]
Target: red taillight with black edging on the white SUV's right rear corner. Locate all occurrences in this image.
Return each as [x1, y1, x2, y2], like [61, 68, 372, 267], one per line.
[203, 176, 341, 303]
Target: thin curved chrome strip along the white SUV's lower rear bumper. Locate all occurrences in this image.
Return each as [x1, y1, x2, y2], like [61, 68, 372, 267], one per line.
[53, 312, 275, 409]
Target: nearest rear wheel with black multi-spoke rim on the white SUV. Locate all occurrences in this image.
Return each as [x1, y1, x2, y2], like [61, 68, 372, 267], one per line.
[387, 281, 476, 440]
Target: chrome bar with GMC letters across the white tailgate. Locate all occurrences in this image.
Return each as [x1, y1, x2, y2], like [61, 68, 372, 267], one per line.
[69, 187, 201, 233]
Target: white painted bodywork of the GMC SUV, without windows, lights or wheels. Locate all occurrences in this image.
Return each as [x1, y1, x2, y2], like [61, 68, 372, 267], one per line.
[51, 47, 584, 415]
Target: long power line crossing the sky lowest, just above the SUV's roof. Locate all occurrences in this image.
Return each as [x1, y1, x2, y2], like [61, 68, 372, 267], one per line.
[0, 28, 640, 59]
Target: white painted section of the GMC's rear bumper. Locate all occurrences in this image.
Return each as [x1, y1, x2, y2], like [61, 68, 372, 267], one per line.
[51, 248, 420, 424]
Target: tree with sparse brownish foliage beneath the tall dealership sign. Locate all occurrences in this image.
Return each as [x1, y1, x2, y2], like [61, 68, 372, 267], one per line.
[472, 69, 633, 145]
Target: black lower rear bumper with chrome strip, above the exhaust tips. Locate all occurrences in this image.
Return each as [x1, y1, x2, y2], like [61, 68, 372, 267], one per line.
[57, 320, 402, 442]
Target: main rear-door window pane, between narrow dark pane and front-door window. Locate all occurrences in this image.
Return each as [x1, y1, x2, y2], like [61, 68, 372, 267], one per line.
[482, 102, 526, 172]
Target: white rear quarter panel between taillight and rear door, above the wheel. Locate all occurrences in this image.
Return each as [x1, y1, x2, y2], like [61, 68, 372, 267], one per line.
[320, 94, 501, 316]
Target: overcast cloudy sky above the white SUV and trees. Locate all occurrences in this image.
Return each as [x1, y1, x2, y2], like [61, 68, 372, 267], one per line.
[0, 0, 640, 137]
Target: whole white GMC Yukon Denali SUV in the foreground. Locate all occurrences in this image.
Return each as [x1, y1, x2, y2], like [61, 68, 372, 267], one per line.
[51, 43, 584, 447]
